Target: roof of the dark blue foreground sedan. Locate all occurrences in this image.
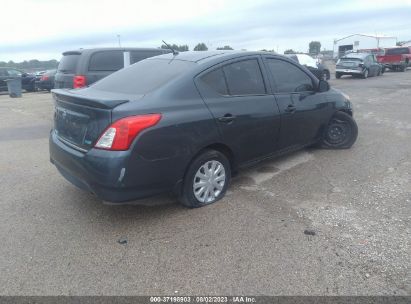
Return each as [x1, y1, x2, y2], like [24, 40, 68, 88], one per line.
[147, 50, 277, 64]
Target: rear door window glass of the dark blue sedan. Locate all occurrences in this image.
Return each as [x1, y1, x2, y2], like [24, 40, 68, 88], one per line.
[223, 59, 266, 95]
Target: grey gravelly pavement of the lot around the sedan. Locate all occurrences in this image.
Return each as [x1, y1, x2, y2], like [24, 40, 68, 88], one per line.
[0, 70, 411, 295]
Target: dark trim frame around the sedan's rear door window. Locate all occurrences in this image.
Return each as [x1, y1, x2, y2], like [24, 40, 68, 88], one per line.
[194, 55, 272, 98]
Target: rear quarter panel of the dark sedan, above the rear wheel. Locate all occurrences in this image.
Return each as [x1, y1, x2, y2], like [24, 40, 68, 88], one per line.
[112, 78, 220, 186]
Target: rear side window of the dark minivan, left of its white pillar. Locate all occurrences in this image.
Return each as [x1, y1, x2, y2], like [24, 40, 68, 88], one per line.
[88, 51, 124, 72]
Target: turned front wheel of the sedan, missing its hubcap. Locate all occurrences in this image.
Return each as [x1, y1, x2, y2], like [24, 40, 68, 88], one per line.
[321, 112, 358, 149]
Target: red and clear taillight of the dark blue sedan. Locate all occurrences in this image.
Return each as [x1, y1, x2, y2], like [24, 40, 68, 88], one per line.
[94, 114, 161, 151]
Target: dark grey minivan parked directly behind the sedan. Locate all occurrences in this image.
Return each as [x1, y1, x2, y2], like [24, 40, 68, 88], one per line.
[55, 48, 171, 89]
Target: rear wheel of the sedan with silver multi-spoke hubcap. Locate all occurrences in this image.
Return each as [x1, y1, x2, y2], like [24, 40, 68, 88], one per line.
[179, 150, 231, 208]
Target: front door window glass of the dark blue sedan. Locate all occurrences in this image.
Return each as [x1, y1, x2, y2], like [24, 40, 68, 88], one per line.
[267, 59, 314, 93]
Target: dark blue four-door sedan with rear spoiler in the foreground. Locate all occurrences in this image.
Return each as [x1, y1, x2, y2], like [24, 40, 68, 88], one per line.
[50, 51, 357, 207]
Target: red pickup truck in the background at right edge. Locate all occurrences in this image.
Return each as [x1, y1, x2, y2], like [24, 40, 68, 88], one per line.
[377, 46, 411, 72]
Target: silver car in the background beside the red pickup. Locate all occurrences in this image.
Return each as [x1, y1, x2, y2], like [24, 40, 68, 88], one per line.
[335, 53, 384, 79]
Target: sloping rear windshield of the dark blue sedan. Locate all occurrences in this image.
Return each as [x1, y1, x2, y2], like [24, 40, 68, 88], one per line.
[92, 59, 196, 95]
